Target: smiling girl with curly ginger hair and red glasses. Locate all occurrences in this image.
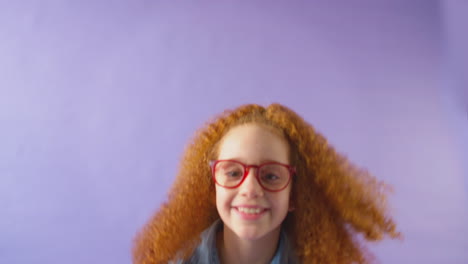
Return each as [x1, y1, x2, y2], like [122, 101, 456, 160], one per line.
[134, 104, 399, 264]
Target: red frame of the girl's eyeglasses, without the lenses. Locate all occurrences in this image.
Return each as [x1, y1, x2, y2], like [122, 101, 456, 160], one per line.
[209, 159, 296, 192]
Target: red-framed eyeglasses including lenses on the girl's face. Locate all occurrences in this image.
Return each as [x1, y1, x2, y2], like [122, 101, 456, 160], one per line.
[210, 160, 296, 192]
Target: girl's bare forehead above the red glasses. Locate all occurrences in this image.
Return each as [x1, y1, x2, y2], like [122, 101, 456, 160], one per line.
[218, 124, 289, 163]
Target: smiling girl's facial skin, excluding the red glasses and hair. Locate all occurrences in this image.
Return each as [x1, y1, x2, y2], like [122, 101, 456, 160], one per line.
[216, 124, 291, 240]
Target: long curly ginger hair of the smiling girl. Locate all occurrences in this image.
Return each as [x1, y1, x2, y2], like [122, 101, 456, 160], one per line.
[133, 104, 400, 264]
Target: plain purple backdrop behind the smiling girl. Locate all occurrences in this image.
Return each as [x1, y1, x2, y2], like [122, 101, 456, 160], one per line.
[0, 0, 468, 264]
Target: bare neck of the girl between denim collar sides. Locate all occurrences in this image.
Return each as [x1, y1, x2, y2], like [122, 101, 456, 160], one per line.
[216, 226, 280, 264]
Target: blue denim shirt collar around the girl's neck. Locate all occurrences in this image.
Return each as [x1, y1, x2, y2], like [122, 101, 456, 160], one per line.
[174, 219, 298, 264]
